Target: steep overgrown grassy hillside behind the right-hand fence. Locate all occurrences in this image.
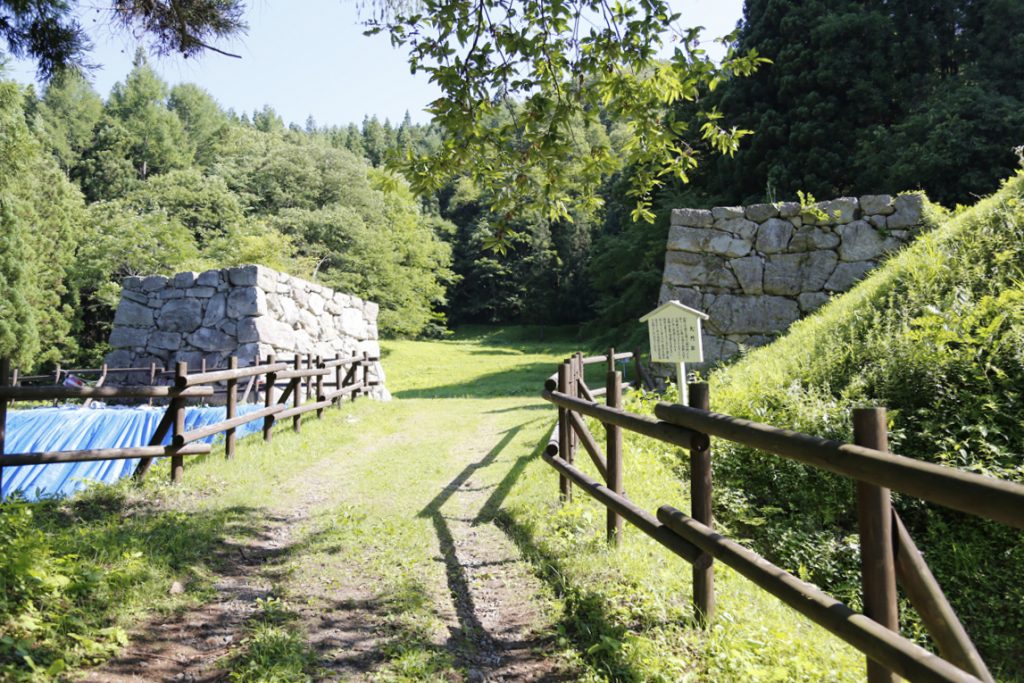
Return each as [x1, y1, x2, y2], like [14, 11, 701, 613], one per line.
[711, 174, 1024, 676]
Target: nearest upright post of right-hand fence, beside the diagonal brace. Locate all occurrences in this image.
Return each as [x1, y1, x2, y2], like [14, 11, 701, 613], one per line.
[853, 408, 899, 683]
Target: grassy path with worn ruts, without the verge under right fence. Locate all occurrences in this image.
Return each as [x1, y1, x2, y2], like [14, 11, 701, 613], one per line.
[83, 331, 589, 681]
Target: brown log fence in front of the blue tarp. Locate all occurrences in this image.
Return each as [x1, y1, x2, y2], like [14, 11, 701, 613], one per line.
[0, 353, 379, 491]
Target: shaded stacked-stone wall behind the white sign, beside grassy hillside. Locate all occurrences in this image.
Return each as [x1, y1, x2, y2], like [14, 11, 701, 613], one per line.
[659, 195, 923, 361]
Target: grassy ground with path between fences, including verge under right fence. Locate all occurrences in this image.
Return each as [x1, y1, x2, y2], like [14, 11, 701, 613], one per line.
[56, 329, 863, 683]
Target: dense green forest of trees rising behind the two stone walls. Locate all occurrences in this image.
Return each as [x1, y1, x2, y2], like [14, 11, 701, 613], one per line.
[0, 0, 1024, 366]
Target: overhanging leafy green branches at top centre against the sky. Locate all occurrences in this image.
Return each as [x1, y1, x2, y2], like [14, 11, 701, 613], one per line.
[367, 0, 766, 251]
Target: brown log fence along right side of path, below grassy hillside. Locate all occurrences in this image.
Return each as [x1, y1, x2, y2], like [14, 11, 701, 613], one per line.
[543, 350, 1024, 683]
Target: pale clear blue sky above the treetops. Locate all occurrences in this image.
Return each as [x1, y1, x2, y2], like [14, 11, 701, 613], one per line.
[9, 0, 742, 125]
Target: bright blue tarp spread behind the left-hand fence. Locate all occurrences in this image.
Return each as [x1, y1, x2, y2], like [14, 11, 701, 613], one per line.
[0, 403, 263, 500]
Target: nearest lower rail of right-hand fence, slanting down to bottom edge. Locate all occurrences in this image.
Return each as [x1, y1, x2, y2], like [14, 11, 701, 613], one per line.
[657, 505, 980, 683]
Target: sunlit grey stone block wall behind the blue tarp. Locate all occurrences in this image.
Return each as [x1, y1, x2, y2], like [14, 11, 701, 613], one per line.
[104, 265, 388, 398]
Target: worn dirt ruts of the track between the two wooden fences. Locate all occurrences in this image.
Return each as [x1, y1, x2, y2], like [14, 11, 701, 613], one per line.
[86, 389, 573, 682]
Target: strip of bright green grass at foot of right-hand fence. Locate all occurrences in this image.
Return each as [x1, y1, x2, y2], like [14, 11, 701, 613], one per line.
[502, 385, 863, 682]
